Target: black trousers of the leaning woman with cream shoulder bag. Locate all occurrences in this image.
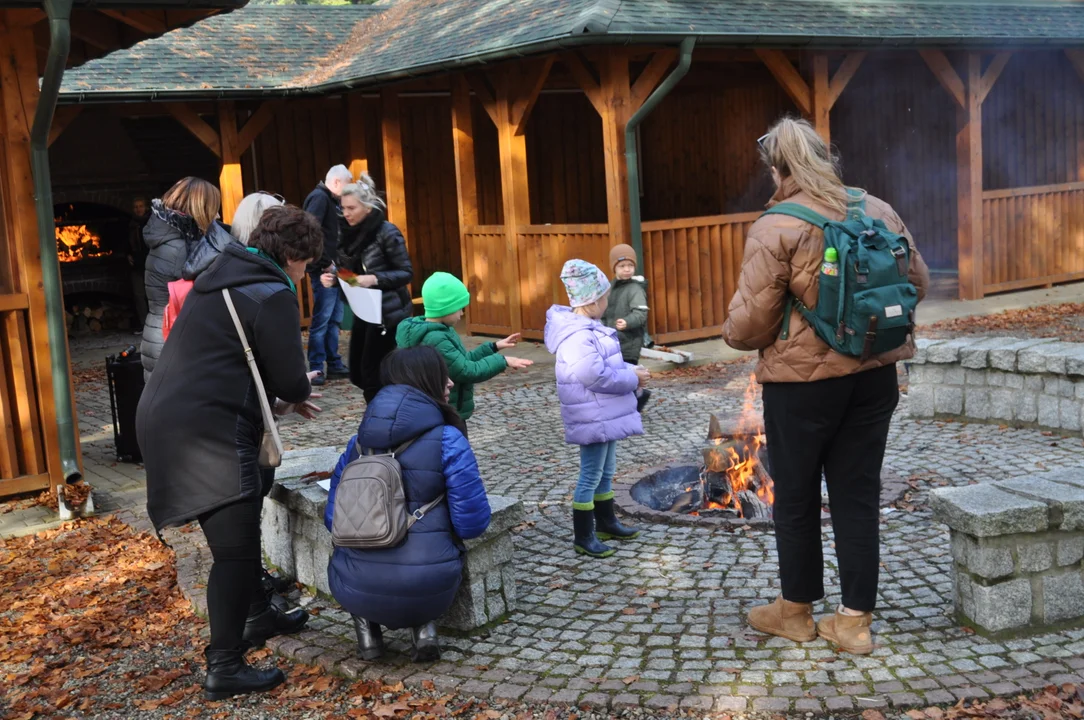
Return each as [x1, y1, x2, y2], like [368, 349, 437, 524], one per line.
[198, 498, 267, 650]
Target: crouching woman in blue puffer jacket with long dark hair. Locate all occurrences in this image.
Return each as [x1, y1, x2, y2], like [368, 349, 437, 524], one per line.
[324, 346, 490, 661]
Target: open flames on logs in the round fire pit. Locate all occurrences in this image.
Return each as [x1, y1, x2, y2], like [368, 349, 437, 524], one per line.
[686, 376, 775, 517]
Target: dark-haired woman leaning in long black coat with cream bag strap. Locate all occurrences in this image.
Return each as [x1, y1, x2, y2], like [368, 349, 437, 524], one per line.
[136, 207, 323, 699]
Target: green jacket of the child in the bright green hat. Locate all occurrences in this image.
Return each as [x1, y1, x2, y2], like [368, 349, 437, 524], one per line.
[396, 318, 508, 420]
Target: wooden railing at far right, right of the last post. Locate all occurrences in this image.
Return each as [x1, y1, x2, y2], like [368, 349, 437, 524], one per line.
[982, 182, 1084, 293]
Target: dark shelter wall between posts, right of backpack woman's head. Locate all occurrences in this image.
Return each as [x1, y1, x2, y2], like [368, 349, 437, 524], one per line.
[831, 52, 957, 270]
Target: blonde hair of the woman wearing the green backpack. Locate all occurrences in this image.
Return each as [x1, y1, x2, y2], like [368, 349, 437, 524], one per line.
[760, 117, 847, 213]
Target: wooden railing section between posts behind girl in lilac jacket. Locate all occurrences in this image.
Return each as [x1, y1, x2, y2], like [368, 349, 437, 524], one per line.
[516, 224, 610, 339]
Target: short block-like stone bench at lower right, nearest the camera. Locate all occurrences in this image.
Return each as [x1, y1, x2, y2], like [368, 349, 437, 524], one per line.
[930, 468, 1084, 637]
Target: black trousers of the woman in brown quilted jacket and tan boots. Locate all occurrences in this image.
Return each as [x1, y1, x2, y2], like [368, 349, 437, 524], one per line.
[763, 365, 900, 612]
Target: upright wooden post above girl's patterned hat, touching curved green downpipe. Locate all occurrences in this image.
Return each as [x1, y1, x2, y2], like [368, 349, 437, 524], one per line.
[602, 50, 634, 246]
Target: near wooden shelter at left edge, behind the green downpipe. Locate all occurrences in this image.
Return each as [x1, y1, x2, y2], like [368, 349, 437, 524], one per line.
[0, 0, 241, 496]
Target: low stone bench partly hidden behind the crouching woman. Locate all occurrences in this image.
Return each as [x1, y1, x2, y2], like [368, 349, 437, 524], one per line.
[262, 448, 524, 632]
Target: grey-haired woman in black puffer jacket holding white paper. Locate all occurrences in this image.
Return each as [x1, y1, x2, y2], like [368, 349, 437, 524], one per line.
[320, 172, 414, 403]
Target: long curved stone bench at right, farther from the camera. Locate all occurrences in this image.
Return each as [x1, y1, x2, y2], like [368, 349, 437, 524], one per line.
[907, 337, 1084, 432]
